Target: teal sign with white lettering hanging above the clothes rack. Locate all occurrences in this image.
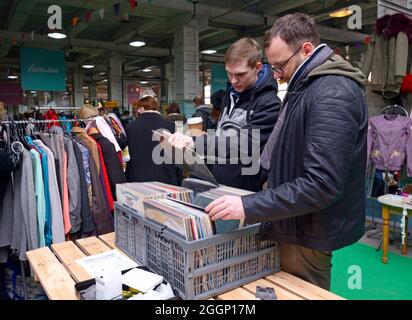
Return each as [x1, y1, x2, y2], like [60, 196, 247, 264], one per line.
[20, 47, 66, 91]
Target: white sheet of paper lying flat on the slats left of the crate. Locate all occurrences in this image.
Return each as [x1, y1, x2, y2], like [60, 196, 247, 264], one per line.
[76, 250, 138, 277]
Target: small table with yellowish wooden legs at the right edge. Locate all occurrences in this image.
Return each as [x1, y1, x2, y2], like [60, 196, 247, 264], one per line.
[378, 194, 412, 263]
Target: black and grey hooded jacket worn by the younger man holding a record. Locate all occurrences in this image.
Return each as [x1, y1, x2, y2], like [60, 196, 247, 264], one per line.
[195, 65, 281, 191]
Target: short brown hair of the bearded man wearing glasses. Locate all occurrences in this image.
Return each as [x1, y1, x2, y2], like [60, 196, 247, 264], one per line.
[263, 13, 320, 50]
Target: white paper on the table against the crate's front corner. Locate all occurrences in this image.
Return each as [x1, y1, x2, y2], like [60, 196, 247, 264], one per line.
[122, 268, 163, 293]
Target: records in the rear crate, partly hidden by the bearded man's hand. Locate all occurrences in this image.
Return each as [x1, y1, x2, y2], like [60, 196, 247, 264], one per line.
[193, 185, 253, 234]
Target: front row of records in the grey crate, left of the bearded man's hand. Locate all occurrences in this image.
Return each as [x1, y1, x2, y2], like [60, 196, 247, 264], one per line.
[144, 199, 214, 241]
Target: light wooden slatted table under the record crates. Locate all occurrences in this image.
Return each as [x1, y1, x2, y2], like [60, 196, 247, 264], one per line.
[27, 233, 343, 300]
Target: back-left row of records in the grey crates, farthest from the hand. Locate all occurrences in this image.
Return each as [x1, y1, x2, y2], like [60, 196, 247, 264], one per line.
[116, 182, 194, 214]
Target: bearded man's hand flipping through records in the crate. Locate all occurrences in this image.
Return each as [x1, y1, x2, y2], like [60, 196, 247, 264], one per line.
[205, 196, 246, 221]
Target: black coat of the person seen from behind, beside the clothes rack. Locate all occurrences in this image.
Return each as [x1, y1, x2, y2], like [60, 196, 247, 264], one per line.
[126, 112, 182, 185]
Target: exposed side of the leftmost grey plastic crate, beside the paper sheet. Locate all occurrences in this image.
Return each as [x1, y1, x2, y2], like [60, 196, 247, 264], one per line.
[114, 203, 146, 265]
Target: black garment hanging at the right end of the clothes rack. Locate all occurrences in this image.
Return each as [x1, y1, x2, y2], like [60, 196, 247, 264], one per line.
[91, 133, 126, 199]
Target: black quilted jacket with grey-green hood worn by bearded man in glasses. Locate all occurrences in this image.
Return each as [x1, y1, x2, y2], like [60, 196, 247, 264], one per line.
[242, 51, 368, 251]
